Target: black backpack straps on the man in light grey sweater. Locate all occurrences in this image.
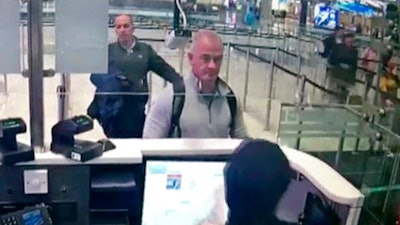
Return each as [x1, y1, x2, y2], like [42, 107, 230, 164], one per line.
[168, 79, 237, 138]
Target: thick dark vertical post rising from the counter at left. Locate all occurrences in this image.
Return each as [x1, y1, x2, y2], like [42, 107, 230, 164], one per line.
[28, 0, 44, 152]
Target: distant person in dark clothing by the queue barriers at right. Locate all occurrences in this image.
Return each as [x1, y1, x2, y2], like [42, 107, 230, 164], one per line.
[327, 33, 358, 104]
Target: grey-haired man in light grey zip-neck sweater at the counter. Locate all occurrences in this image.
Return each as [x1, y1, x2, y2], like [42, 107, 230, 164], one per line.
[143, 30, 247, 138]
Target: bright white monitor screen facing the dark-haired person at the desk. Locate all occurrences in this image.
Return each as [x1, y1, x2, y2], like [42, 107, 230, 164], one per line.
[142, 161, 228, 225]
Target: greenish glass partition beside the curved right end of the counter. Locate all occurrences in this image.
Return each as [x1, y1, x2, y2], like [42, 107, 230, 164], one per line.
[278, 104, 400, 224]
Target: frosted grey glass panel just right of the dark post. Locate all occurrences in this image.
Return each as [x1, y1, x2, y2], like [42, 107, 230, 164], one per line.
[55, 0, 108, 73]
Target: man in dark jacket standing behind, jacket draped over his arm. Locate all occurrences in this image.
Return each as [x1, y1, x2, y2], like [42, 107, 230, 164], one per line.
[87, 15, 183, 138]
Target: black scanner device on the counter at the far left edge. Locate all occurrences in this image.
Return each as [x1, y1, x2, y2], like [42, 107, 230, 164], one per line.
[0, 118, 35, 165]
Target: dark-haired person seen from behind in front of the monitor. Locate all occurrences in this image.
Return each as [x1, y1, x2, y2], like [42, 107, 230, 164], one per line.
[224, 140, 291, 225]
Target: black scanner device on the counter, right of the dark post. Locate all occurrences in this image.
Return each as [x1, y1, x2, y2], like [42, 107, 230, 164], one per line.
[50, 115, 115, 162]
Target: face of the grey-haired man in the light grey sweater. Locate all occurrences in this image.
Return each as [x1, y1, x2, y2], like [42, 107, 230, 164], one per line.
[188, 37, 224, 81]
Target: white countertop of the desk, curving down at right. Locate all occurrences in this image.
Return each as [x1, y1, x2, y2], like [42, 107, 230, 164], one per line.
[14, 139, 364, 207]
